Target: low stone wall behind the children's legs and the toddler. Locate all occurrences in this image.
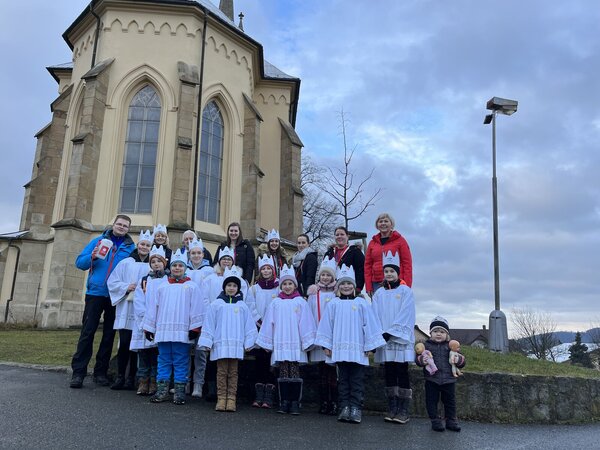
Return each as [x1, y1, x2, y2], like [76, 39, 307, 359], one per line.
[234, 361, 600, 424]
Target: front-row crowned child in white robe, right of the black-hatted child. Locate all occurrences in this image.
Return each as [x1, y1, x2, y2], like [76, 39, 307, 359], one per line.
[256, 265, 316, 415]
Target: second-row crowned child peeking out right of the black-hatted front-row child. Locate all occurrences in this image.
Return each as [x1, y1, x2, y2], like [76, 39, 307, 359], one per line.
[246, 254, 279, 409]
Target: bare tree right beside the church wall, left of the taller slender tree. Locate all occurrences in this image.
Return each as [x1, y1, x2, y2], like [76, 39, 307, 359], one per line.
[300, 154, 339, 251]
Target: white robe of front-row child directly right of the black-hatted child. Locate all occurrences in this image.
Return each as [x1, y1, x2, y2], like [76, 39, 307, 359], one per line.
[256, 296, 316, 365]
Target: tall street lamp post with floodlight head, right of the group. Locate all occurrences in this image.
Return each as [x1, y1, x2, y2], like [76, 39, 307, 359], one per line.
[483, 97, 518, 353]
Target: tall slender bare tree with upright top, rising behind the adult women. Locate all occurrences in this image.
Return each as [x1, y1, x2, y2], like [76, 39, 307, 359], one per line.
[324, 108, 381, 228]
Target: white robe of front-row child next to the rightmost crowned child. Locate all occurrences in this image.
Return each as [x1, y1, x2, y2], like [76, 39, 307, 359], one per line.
[315, 297, 385, 366]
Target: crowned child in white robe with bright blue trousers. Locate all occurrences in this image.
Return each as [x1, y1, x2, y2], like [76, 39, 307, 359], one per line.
[143, 250, 206, 405]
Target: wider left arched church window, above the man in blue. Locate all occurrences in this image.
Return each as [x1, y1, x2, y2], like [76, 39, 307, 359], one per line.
[119, 85, 160, 214]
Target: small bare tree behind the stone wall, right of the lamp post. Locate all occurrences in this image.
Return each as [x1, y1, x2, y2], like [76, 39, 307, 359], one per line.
[511, 307, 560, 361]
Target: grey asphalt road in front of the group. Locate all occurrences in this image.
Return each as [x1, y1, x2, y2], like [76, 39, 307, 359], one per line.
[0, 364, 600, 450]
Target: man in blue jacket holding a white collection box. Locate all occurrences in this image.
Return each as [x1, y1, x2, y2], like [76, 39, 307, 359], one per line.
[70, 214, 135, 388]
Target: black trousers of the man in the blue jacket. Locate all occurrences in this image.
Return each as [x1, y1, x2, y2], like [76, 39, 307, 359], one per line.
[71, 294, 115, 376]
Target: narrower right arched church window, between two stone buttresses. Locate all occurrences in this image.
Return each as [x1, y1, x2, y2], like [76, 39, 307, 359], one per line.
[196, 101, 224, 223]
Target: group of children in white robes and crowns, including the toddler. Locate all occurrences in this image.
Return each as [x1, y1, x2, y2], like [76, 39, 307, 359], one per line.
[108, 225, 465, 431]
